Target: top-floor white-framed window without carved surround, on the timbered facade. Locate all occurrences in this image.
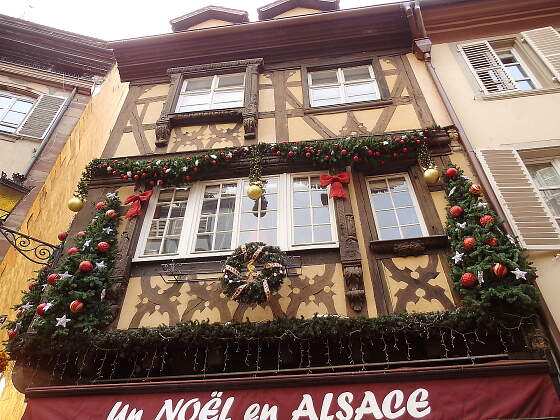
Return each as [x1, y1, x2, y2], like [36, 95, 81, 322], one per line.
[307, 65, 380, 107]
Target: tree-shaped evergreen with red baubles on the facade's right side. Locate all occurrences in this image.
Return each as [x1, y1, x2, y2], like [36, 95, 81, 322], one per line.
[443, 165, 538, 313]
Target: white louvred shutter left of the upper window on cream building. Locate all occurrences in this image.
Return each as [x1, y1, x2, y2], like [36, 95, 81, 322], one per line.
[458, 41, 517, 93]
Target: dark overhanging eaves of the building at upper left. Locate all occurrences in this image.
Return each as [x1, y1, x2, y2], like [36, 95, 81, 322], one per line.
[0, 15, 114, 77]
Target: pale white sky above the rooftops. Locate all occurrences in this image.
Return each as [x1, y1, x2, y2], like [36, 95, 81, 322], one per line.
[0, 0, 397, 41]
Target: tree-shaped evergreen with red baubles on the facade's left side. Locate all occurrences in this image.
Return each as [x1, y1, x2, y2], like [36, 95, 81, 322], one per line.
[5, 193, 121, 351]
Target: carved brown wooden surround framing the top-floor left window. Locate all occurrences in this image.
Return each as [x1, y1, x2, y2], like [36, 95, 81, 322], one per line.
[156, 58, 263, 147]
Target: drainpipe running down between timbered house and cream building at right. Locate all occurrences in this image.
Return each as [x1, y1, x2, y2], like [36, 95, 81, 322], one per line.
[403, 0, 514, 234]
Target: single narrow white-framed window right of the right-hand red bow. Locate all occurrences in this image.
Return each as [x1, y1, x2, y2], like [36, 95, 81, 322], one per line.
[367, 174, 428, 240]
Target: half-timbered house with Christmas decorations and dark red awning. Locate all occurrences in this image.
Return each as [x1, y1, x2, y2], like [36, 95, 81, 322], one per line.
[0, 0, 560, 420]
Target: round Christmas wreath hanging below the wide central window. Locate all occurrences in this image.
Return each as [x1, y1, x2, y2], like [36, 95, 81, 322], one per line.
[222, 242, 286, 304]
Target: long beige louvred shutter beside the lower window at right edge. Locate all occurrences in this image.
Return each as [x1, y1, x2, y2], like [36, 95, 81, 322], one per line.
[476, 148, 560, 249]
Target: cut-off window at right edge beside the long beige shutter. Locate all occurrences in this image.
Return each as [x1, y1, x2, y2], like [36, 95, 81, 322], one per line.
[525, 159, 560, 224]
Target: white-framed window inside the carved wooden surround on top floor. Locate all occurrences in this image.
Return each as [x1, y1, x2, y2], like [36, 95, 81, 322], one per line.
[175, 73, 245, 112]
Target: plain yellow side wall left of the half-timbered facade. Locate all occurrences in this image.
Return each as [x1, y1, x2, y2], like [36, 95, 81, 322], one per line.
[0, 69, 128, 420]
